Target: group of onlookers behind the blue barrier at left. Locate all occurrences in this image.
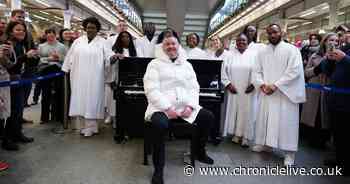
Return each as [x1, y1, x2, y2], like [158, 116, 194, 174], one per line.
[0, 9, 73, 170]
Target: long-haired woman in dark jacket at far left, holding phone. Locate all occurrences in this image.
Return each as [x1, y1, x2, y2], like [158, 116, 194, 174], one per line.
[2, 22, 38, 150]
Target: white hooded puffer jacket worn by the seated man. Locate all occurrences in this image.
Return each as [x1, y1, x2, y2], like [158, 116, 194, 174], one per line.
[143, 47, 201, 123]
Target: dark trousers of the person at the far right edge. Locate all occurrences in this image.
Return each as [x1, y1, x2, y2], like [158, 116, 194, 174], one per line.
[330, 110, 350, 174]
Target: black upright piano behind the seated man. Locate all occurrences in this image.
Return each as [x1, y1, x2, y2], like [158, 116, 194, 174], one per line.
[114, 57, 223, 143]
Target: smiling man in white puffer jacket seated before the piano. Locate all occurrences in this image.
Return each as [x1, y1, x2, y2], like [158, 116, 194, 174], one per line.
[143, 36, 214, 184]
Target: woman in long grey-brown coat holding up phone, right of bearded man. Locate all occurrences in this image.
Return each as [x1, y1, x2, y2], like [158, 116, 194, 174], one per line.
[300, 33, 339, 148]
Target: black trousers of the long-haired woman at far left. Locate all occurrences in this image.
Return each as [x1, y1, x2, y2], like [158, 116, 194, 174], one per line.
[4, 86, 25, 140]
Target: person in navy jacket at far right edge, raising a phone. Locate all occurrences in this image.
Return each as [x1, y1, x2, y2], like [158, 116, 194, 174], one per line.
[313, 32, 350, 176]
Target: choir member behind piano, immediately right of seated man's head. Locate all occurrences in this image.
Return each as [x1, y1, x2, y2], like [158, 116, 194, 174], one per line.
[186, 33, 208, 59]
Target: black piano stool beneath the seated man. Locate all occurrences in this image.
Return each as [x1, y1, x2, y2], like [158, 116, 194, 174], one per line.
[143, 120, 196, 167]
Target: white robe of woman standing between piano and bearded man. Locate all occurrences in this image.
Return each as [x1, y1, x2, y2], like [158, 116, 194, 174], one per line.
[221, 48, 257, 140]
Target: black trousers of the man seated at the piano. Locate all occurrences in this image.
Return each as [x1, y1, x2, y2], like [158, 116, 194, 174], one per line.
[151, 108, 214, 171]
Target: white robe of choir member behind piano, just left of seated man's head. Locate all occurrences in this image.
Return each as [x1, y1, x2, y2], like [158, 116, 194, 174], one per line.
[135, 36, 157, 58]
